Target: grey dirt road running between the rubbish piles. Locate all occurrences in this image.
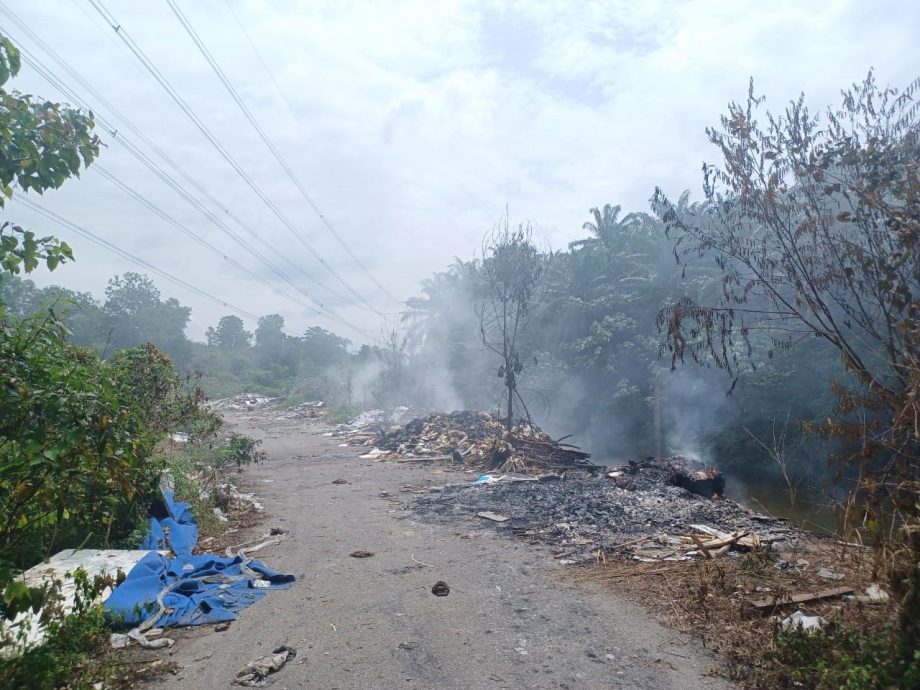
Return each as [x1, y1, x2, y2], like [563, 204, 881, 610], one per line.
[154, 415, 731, 690]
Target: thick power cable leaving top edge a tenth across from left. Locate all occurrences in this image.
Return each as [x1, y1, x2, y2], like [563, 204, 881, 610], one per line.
[89, 0, 380, 314]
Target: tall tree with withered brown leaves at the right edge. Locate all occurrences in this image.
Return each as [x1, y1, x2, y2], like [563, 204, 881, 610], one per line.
[653, 73, 920, 654]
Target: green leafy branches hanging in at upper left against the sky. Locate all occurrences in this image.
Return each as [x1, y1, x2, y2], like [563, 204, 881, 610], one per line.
[0, 35, 100, 273]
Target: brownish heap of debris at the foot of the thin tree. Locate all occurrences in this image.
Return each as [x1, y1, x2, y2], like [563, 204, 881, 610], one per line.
[356, 411, 596, 472]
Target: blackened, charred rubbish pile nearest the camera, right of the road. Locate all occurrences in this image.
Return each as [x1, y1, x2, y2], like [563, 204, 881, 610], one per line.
[412, 458, 794, 562]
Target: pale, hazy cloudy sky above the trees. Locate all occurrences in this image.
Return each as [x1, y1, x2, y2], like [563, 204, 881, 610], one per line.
[0, 0, 920, 344]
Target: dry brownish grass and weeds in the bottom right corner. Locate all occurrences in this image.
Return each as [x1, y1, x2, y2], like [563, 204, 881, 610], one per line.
[571, 535, 920, 690]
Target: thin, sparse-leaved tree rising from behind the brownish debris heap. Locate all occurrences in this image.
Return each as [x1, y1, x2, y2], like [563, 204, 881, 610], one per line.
[477, 219, 548, 431]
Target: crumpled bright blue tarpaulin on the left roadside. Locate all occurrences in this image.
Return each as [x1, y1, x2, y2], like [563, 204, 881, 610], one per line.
[105, 490, 294, 627]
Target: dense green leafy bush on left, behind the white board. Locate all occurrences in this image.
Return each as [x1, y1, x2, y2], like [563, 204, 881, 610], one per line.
[0, 313, 219, 568]
